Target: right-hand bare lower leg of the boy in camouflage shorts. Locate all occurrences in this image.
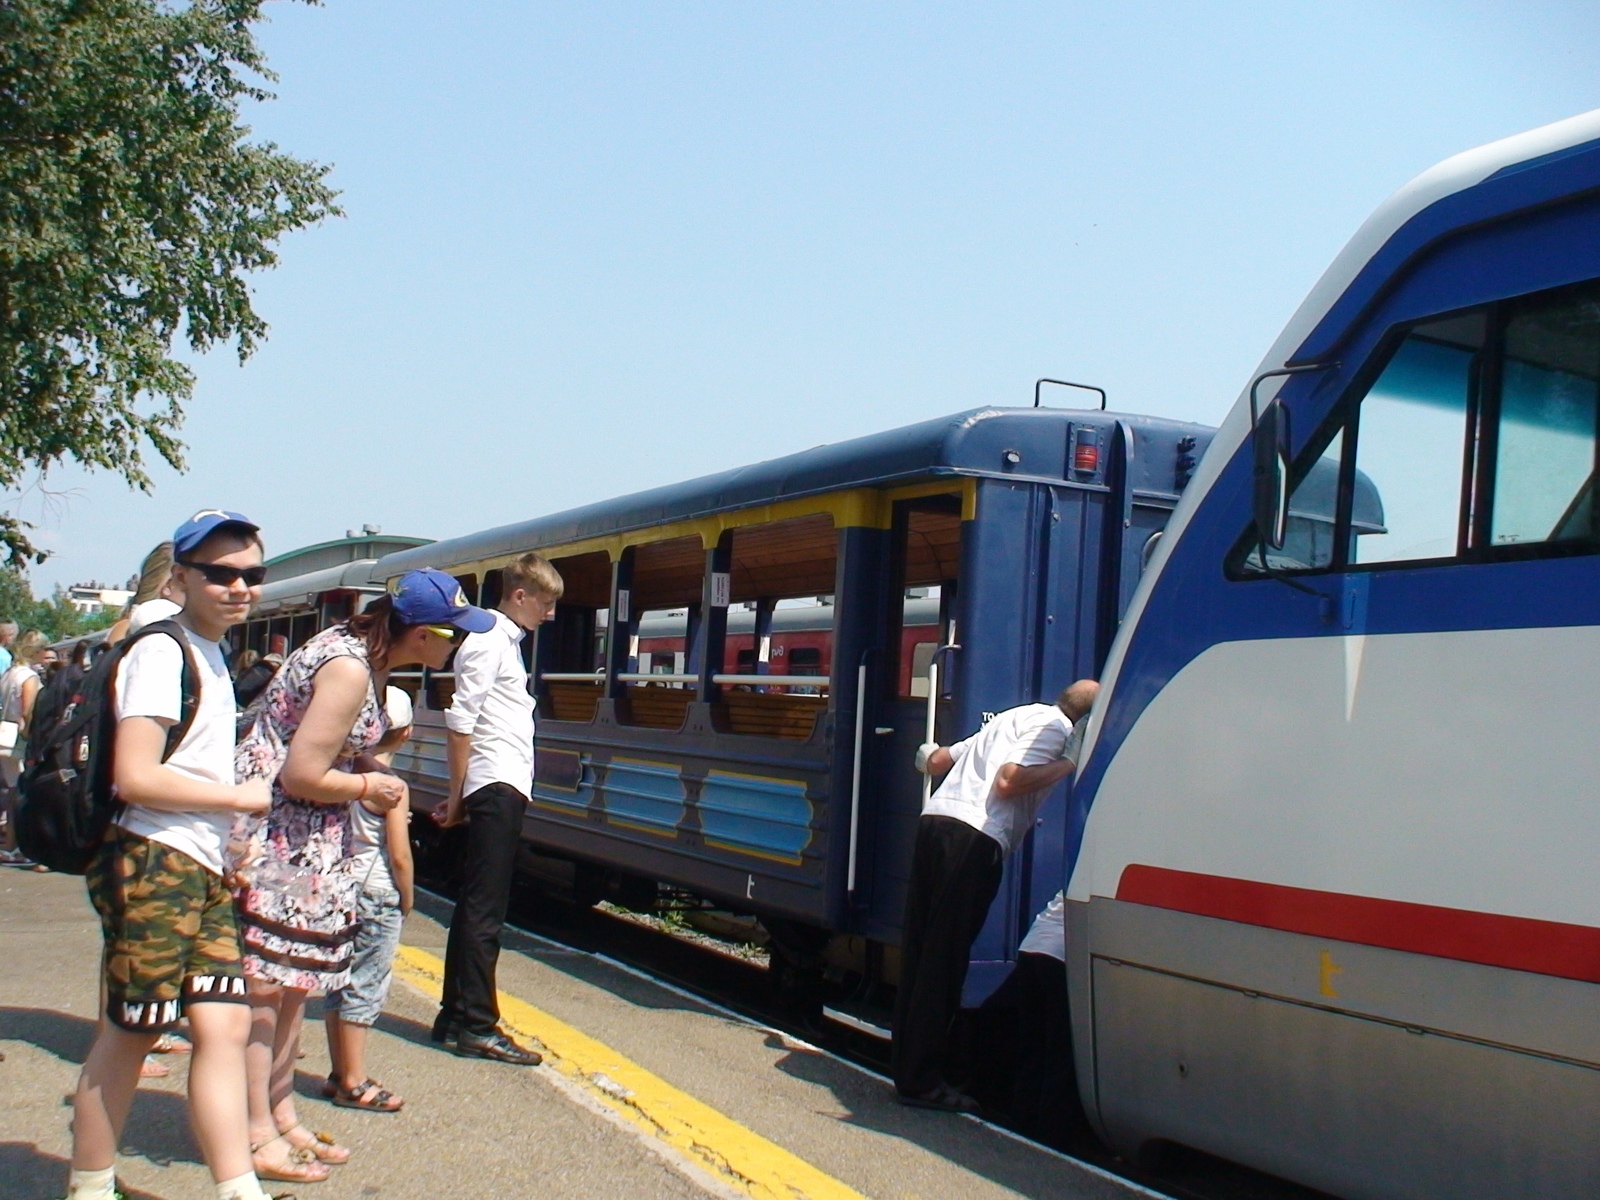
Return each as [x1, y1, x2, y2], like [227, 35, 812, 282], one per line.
[189, 1003, 254, 1182]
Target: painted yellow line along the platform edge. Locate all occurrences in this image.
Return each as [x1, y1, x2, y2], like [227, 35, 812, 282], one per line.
[395, 946, 866, 1200]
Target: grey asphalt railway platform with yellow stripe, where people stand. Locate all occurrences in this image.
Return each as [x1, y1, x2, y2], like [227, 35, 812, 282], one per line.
[0, 870, 1157, 1200]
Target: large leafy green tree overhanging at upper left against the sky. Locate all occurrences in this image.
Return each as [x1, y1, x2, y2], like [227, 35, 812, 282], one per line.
[0, 0, 339, 565]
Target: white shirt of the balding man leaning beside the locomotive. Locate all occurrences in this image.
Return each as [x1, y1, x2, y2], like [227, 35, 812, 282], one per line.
[922, 704, 1072, 854]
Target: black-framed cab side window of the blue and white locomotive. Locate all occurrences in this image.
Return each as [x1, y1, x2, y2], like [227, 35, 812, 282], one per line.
[1230, 282, 1600, 578]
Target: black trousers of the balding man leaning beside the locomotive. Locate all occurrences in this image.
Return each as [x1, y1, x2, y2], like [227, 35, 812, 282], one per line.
[890, 816, 1005, 1096]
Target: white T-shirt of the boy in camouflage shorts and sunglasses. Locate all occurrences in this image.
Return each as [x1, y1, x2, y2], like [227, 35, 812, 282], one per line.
[115, 629, 237, 875]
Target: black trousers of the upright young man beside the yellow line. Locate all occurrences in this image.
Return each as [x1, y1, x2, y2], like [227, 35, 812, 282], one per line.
[438, 784, 528, 1034]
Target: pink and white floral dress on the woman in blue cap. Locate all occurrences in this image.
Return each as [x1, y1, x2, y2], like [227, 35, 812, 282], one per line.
[229, 626, 389, 992]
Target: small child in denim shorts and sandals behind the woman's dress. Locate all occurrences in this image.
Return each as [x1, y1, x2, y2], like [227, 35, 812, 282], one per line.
[322, 688, 413, 1112]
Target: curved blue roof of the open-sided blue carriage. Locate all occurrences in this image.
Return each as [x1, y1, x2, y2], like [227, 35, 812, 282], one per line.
[374, 406, 1213, 579]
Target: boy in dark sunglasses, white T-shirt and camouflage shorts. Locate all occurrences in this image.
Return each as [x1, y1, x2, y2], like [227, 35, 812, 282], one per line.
[69, 509, 270, 1200]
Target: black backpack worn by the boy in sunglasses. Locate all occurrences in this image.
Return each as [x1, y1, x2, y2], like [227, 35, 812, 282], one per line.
[16, 621, 200, 875]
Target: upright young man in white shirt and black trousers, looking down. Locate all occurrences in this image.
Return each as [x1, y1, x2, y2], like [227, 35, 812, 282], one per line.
[434, 554, 563, 1066]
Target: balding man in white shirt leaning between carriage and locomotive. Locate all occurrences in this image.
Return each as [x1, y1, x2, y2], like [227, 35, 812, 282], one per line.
[891, 680, 1099, 1112]
